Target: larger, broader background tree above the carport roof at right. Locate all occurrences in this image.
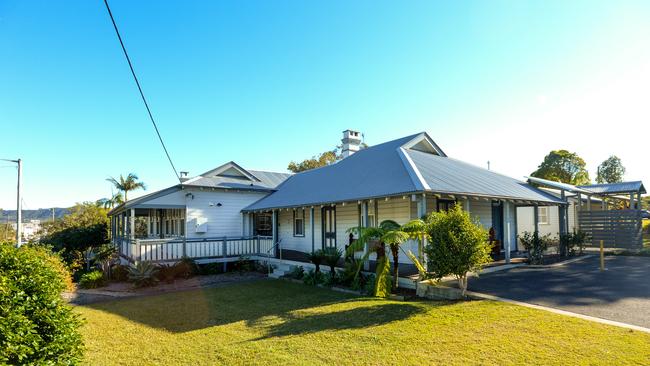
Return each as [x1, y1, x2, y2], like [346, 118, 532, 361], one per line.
[530, 150, 591, 185]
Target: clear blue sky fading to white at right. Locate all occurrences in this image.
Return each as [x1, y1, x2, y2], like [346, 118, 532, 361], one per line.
[0, 0, 650, 209]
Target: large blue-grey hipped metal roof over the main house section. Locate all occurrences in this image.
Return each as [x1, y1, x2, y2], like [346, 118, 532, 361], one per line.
[244, 132, 564, 211]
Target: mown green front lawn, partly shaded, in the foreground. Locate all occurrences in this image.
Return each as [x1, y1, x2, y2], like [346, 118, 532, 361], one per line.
[76, 280, 650, 365]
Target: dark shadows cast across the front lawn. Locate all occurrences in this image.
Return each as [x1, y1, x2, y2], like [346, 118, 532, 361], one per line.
[86, 281, 426, 335]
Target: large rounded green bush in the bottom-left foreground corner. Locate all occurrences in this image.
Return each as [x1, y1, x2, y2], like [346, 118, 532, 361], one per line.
[0, 244, 83, 364]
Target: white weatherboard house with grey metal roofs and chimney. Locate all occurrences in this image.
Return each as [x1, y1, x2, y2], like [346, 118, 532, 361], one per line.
[110, 130, 566, 274]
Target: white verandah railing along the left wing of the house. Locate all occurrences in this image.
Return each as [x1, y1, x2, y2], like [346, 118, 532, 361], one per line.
[116, 236, 273, 262]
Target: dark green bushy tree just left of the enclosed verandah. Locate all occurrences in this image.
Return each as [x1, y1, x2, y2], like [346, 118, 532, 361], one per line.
[40, 202, 109, 262]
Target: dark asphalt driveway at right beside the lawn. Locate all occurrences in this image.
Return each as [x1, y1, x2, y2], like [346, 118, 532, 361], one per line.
[468, 256, 650, 328]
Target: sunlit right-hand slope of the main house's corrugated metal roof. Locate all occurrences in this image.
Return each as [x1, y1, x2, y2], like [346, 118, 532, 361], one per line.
[407, 150, 562, 203]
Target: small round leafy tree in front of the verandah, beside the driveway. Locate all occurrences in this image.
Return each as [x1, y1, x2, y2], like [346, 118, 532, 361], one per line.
[425, 205, 491, 296]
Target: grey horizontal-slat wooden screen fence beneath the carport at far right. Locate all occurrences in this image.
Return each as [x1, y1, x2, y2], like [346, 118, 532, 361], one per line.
[578, 210, 643, 249]
